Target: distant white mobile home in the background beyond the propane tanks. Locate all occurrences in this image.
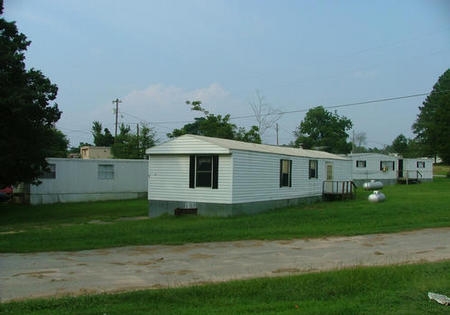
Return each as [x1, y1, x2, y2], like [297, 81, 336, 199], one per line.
[349, 153, 433, 186]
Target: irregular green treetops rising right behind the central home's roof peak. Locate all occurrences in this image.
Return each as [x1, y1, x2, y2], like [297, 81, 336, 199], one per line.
[167, 101, 261, 143]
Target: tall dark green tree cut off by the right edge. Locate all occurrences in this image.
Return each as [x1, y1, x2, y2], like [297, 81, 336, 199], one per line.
[412, 69, 450, 164]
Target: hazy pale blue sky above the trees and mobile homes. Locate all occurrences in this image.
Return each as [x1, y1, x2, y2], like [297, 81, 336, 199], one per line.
[3, 0, 450, 148]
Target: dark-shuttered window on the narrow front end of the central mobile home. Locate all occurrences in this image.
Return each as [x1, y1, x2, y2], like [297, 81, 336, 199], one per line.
[189, 155, 219, 189]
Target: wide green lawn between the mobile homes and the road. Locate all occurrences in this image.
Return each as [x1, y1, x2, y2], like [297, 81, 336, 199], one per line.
[0, 178, 450, 252]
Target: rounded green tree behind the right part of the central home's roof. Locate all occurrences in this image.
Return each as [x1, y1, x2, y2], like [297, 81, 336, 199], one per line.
[294, 106, 352, 154]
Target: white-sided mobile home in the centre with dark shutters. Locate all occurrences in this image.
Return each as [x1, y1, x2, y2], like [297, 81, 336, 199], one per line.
[146, 135, 351, 217]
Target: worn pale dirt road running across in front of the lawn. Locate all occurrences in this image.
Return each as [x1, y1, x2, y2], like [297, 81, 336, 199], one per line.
[0, 228, 450, 302]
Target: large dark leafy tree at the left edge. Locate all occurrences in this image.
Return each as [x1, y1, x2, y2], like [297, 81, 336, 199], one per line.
[0, 1, 63, 186]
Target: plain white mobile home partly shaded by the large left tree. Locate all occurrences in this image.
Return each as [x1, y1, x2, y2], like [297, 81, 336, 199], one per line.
[24, 158, 148, 205]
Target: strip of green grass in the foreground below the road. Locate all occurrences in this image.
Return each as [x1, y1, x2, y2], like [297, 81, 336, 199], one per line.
[0, 261, 450, 315]
